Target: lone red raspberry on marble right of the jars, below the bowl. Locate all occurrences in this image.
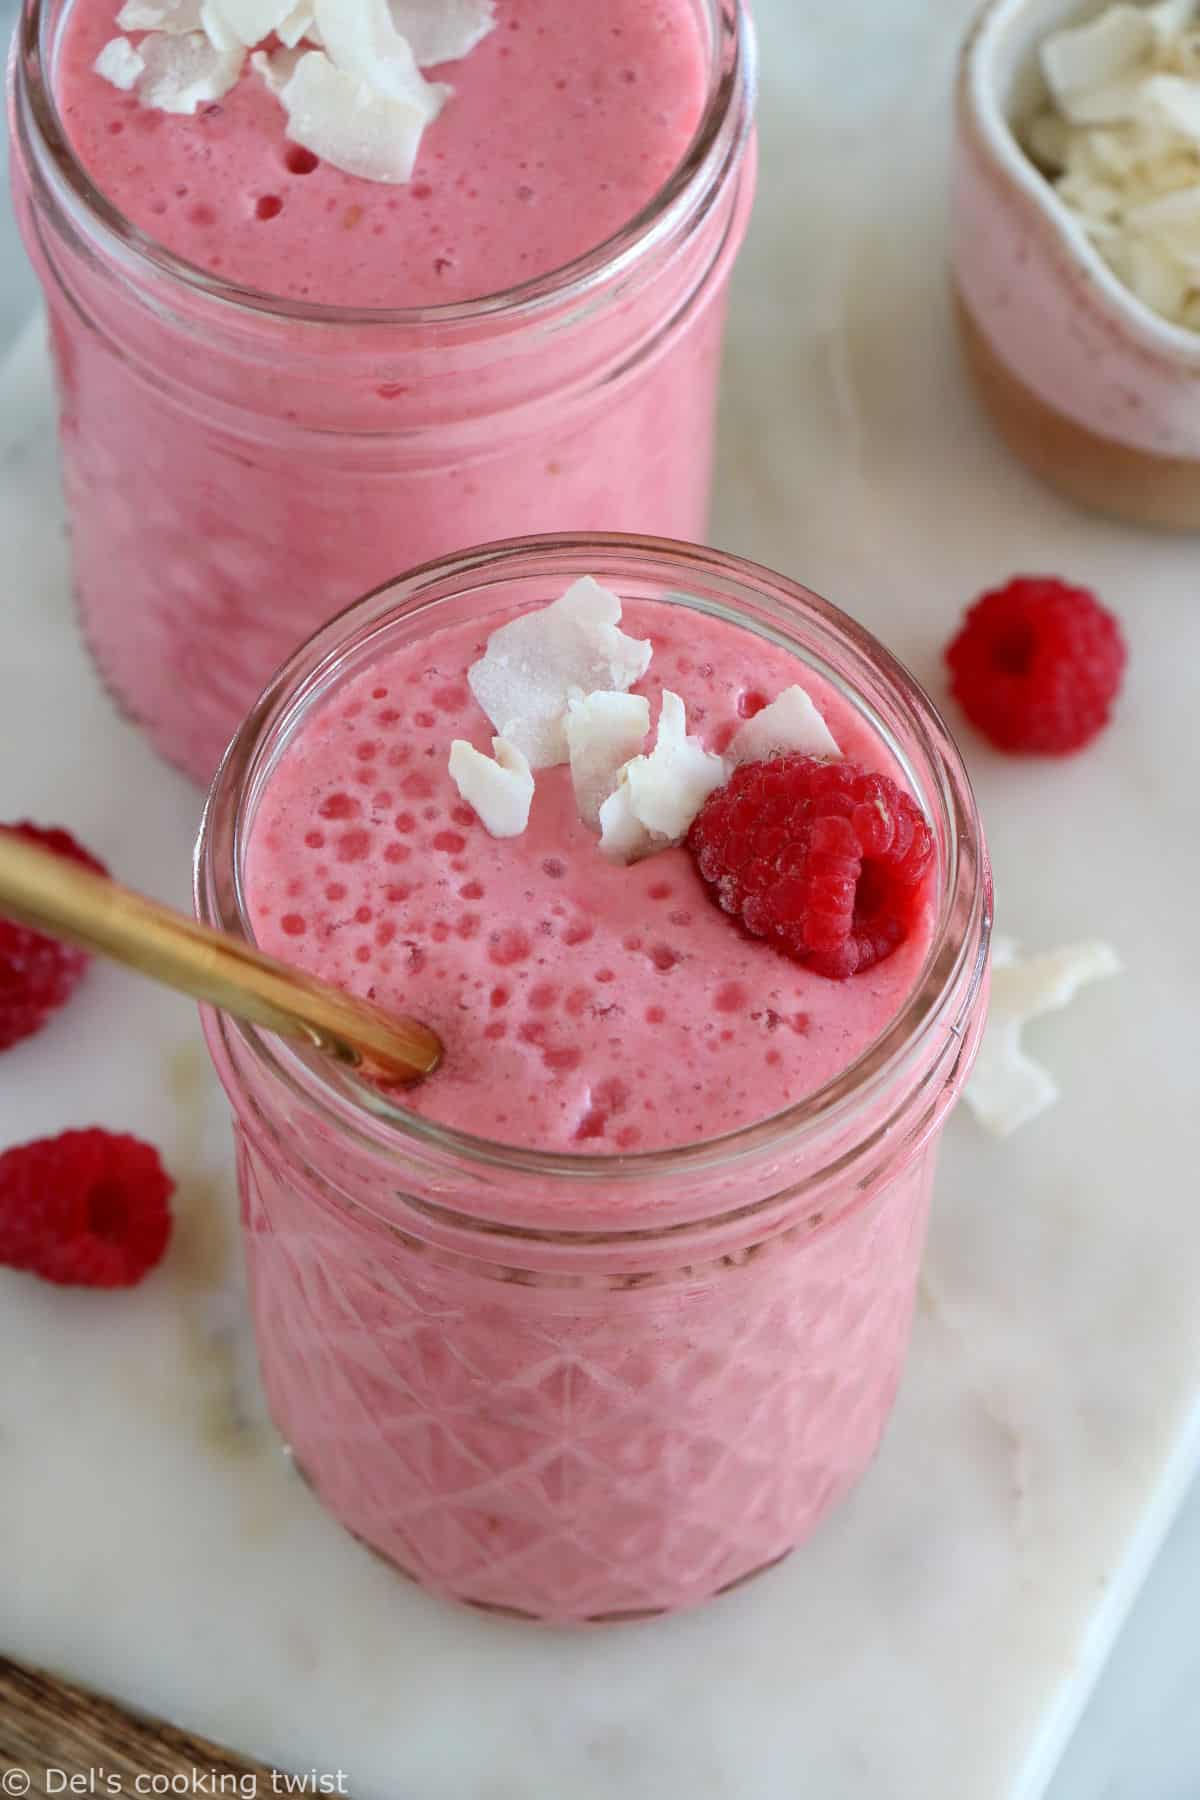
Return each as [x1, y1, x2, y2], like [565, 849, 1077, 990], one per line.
[946, 576, 1126, 756]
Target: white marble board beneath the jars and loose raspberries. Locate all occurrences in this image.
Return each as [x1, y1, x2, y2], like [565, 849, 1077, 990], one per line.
[0, 0, 1200, 1800]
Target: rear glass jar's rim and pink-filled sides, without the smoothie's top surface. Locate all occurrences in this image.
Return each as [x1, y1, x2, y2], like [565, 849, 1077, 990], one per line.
[11, 0, 754, 783]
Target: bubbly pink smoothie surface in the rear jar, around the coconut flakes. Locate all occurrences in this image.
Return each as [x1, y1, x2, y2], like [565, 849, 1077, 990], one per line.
[56, 0, 707, 308]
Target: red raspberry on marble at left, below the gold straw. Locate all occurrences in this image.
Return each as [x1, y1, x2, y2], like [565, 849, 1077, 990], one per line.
[0, 1127, 175, 1287]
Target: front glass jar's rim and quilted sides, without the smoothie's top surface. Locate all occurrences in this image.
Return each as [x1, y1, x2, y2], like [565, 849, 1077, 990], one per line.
[196, 535, 991, 1622]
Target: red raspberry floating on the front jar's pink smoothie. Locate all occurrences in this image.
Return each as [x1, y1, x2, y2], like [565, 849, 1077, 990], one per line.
[687, 756, 934, 981]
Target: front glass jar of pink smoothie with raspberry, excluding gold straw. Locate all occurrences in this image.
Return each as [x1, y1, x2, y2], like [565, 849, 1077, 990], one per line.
[198, 540, 988, 1620]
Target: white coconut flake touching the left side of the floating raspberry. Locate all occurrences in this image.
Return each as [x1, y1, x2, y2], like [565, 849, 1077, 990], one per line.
[599, 688, 727, 862]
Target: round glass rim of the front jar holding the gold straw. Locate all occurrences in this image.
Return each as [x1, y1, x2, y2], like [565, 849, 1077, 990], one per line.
[194, 533, 991, 1186]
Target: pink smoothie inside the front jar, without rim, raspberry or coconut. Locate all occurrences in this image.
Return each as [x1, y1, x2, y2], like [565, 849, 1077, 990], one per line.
[209, 601, 973, 1622]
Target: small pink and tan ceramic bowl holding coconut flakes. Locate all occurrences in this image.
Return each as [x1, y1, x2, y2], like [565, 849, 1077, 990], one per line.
[952, 0, 1200, 529]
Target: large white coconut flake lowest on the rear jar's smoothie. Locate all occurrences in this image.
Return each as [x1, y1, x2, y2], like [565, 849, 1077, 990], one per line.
[282, 50, 440, 182]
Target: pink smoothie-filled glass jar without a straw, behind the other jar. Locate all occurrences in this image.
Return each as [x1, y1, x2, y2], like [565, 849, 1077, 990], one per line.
[13, 0, 752, 781]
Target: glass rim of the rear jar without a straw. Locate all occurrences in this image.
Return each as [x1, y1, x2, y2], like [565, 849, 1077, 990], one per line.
[13, 0, 757, 329]
